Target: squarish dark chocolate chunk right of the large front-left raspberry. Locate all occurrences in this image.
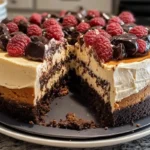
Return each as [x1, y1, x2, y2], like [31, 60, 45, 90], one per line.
[25, 36, 45, 61]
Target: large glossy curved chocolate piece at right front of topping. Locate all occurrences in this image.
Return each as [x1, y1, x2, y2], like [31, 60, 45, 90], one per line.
[111, 33, 138, 57]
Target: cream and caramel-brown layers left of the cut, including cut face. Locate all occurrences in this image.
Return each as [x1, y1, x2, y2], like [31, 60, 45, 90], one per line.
[0, 39, 67, 106]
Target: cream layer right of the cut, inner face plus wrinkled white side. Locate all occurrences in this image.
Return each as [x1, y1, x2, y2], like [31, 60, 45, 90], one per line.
[76, 44, 150, 107]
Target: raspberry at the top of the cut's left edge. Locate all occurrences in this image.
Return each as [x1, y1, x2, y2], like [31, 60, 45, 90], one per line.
[46, 25, 64, 41]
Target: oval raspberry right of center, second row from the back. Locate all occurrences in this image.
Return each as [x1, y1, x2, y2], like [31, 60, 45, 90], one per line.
[90, 17, 106, 27]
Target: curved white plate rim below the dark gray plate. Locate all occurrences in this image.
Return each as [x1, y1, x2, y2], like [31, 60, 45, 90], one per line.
[0, 124, 150, 148]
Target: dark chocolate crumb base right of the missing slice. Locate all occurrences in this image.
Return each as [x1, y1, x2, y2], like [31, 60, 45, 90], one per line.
[70, 71, 150, 127]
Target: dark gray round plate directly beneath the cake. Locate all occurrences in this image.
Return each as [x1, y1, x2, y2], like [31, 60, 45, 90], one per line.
[0, 93, 150, 140]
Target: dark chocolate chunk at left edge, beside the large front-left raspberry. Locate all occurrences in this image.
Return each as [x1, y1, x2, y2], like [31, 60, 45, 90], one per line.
[0, 34, 10, 51]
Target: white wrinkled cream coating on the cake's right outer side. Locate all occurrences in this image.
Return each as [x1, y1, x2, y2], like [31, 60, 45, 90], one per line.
[110, 59, 150, 101]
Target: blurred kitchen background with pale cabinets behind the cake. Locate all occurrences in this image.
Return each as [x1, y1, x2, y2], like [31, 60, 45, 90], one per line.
[0, 0, 150, 25]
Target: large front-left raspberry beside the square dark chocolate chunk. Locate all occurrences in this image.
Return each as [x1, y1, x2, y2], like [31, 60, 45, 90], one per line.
[7, 34, 30, 57]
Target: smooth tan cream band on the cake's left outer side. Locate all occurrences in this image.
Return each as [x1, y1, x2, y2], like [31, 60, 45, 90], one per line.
[0, 52, 40, 89]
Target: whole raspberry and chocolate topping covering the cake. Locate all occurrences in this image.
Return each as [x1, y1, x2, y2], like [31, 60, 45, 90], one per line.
[0, 8, 150, 65]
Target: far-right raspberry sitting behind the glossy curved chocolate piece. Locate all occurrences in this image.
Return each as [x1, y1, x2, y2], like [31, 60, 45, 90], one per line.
[129, 26, 148, 38]
